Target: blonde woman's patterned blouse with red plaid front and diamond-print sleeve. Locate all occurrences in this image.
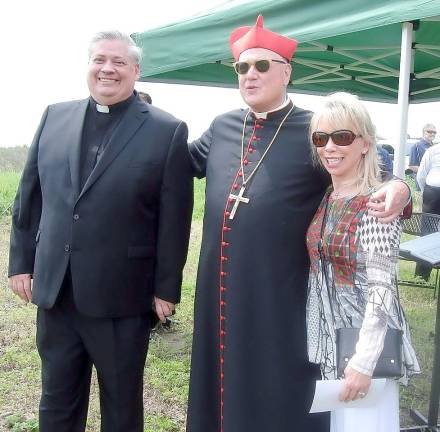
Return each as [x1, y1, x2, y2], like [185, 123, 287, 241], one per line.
[307, 190, 420, 381]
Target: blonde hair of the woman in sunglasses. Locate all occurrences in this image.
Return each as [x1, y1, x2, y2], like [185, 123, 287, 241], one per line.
[309, 92, 380, 194]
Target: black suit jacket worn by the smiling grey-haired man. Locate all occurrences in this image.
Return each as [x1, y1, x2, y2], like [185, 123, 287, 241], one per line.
[9, 97, 193, 317]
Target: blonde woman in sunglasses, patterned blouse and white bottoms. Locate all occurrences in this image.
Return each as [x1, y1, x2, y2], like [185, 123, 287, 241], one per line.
[306, 93, 420, 432]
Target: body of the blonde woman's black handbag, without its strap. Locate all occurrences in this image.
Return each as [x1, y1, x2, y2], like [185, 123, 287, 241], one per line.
[335, 327, 403, 378]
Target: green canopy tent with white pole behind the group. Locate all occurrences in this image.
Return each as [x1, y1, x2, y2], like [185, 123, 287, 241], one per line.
[132, 0, 440, 176]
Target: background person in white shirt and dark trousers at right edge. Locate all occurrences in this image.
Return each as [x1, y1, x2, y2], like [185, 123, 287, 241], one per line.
[415, 144, 440, 281]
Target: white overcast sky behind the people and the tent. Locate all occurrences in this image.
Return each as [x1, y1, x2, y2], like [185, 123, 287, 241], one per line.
[0, 0, 440, 146]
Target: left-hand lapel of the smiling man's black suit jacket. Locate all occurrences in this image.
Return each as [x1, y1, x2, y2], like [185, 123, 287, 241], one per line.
[69, 99, 89, 198]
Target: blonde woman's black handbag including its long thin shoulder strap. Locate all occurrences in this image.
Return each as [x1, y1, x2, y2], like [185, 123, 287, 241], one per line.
[318, 197, 403, 378]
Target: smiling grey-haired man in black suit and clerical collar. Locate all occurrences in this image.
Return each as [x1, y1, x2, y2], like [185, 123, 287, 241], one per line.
[9, 32, 193, 432]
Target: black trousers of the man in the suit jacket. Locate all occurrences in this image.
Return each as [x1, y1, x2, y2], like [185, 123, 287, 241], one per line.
[37, 271, 150, 432]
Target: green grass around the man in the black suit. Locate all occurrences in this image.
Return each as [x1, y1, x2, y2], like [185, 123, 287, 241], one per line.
[0, 172, 205, 432]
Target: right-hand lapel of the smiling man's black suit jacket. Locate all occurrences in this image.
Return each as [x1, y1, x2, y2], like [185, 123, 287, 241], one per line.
[78, 98, 148, 199]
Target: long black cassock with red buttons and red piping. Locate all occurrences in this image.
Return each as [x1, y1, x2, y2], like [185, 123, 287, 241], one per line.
[187, 102, 329, 432]
